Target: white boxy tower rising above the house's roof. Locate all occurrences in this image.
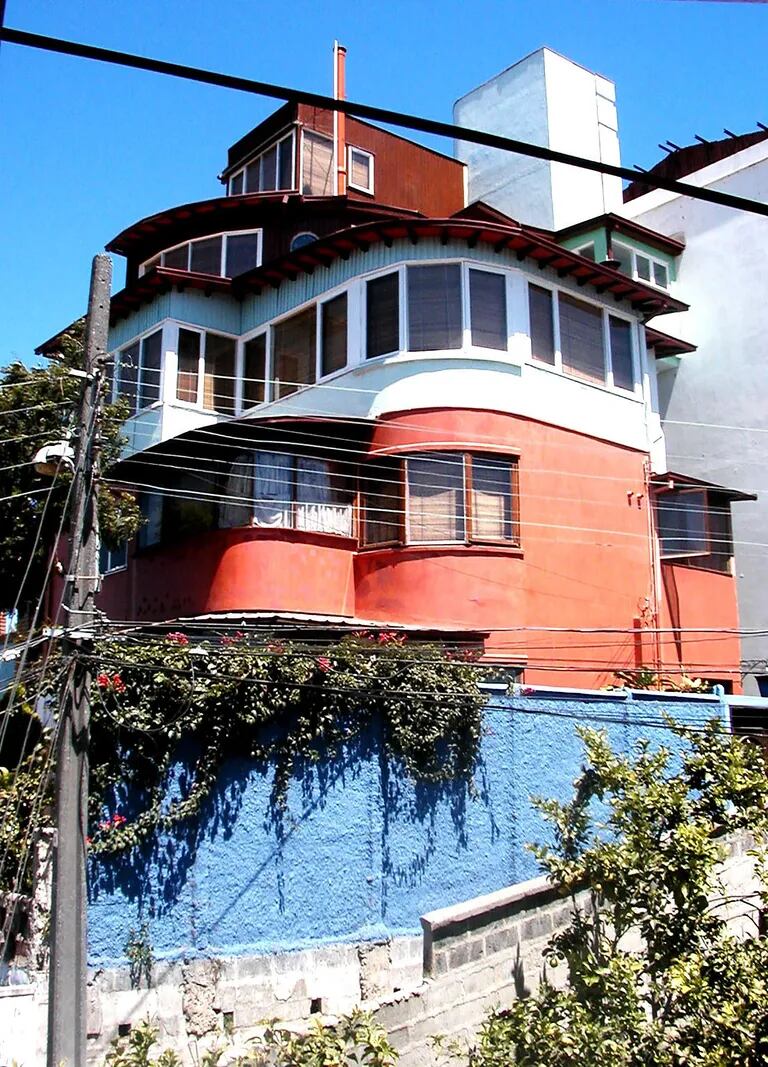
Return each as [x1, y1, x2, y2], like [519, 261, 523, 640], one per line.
[453, 48, 621, 229]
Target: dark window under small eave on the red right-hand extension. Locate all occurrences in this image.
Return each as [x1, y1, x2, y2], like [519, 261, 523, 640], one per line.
[656, 489, 733, 574]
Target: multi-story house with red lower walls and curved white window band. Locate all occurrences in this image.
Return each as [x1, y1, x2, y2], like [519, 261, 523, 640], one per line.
[38, 50, 745, 687]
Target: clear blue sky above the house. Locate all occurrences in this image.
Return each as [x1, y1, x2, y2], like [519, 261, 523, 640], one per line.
[0, 0, 768, 364]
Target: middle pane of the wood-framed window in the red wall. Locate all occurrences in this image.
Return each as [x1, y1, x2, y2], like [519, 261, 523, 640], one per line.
[405, 452, 464, 541]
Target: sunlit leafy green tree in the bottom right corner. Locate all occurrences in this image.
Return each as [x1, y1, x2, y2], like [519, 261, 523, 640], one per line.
[470, 723, 768, 1067]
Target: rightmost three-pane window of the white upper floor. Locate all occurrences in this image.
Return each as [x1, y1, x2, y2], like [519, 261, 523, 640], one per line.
[528, 283, 637, 393]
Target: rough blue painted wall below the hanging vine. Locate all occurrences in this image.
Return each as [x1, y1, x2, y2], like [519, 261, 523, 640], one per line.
[90, 694, 724, 966]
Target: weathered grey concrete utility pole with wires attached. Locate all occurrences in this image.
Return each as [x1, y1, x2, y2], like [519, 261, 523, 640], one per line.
[48, 254, 112, 1067]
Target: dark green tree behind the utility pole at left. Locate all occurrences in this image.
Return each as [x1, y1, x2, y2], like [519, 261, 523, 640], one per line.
[0, 319, 142, 615]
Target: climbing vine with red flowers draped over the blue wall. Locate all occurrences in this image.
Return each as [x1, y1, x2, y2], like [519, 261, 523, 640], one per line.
[90, 633, 484, 853]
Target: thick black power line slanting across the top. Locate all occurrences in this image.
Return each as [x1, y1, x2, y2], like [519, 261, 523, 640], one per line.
[0, 27, 768, 216]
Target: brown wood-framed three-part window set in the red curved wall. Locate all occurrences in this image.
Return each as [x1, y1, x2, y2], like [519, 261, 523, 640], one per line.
[363, 452, 519, 545]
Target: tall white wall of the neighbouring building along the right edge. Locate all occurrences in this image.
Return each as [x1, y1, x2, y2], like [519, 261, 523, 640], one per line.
[624, 142, 768, 692]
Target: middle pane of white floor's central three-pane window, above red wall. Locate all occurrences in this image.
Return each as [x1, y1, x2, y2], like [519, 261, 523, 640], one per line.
[407, 264, 462, 352]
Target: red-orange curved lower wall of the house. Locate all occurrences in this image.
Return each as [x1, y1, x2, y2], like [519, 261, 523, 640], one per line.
[100, 410, 739, 687]
